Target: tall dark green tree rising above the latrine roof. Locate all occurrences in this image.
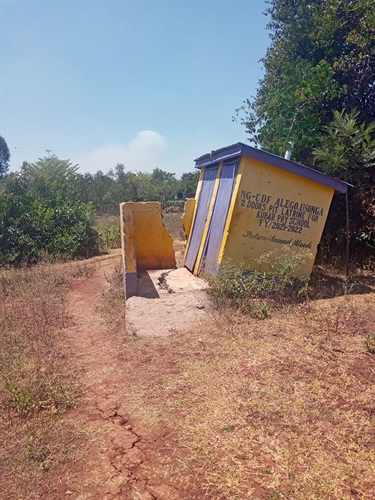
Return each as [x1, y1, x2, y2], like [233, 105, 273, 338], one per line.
[237, 0, 375, 164]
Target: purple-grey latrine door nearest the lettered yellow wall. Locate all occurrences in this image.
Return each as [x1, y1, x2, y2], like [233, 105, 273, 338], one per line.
[200, 162, 238, 274]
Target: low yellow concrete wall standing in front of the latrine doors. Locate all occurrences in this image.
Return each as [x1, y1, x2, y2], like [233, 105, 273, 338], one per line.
[120, 202, 176, 297]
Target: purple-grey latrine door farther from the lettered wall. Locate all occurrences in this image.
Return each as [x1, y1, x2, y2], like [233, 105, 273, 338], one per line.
[185, 166, 218, 272]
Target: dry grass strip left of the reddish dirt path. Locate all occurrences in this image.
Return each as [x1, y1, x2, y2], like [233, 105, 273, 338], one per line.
[0, 264, 83, 498]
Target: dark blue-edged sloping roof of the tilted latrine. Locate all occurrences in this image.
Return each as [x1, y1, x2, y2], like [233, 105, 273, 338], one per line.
[195, 142, 352, 193]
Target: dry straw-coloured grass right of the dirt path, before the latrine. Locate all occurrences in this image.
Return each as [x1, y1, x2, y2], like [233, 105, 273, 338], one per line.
[108, 264, 375, 500]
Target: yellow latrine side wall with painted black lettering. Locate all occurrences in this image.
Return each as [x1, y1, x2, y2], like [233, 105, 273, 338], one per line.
[219, 157, 334, 276]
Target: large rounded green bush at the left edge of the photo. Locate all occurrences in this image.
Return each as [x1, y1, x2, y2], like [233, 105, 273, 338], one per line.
[0, 156, 98, 265]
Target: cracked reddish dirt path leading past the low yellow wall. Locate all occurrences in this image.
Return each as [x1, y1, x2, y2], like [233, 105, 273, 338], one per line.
[49, 256, 207, 500]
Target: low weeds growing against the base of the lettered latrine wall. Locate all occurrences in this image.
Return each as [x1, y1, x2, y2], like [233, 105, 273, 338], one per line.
[207, 249, 309, 312]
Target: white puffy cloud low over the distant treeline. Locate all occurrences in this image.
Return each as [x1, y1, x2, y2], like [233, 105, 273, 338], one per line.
[72, 130, 168, 173]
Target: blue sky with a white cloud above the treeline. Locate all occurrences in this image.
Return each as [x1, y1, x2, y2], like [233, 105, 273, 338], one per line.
[0, 0, 269, 176]
